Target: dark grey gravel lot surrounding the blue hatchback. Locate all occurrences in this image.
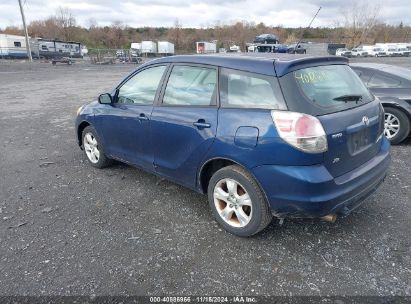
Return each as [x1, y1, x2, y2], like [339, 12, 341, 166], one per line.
[0, 58, 411, 296]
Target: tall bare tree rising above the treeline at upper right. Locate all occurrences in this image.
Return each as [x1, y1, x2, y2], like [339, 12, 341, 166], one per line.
[342, 0, 381, 47]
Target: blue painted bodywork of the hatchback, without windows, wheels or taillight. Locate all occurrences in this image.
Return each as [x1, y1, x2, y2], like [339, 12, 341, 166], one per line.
[76, 54, 390, 217]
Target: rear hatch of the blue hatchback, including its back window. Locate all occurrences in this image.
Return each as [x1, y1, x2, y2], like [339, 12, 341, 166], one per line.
[280, 64, 383, 177]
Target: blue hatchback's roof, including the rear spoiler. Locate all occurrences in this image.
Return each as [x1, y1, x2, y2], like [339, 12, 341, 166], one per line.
[143, 53, 348, 77]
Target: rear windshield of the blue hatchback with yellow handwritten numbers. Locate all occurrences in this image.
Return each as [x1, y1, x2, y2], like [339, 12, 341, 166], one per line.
[280, 65, 374, 116]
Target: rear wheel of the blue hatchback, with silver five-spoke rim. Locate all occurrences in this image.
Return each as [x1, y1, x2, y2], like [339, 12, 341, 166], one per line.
[208, 165, 272, 237]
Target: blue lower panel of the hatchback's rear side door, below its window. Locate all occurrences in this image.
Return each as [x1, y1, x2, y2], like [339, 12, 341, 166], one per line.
[151, 106, 218, 188]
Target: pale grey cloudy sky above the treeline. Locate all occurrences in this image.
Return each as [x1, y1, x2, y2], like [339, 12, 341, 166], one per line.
[0, 0, 411, 28]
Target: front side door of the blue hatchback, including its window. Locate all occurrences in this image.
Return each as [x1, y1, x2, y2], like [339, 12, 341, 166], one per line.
[95, 65, 167, 169]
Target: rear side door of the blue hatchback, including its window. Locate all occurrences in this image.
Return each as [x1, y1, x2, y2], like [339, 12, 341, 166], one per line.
[151, 64, 218, 187]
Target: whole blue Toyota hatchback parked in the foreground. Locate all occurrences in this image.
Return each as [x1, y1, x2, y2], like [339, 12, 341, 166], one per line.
[76, 53, 390, 236]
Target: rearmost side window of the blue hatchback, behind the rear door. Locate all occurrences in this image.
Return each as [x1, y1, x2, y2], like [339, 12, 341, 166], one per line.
[220, 68, 286, 109]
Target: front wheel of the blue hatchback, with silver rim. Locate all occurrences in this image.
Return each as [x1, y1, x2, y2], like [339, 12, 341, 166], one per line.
[81, 126, 112, 169]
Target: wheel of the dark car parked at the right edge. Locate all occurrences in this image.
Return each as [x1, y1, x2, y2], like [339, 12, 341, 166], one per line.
[384, 107, 410, 145]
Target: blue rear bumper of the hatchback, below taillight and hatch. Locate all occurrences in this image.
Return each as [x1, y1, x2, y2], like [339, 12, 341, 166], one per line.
[253, 137, 390, 218]
